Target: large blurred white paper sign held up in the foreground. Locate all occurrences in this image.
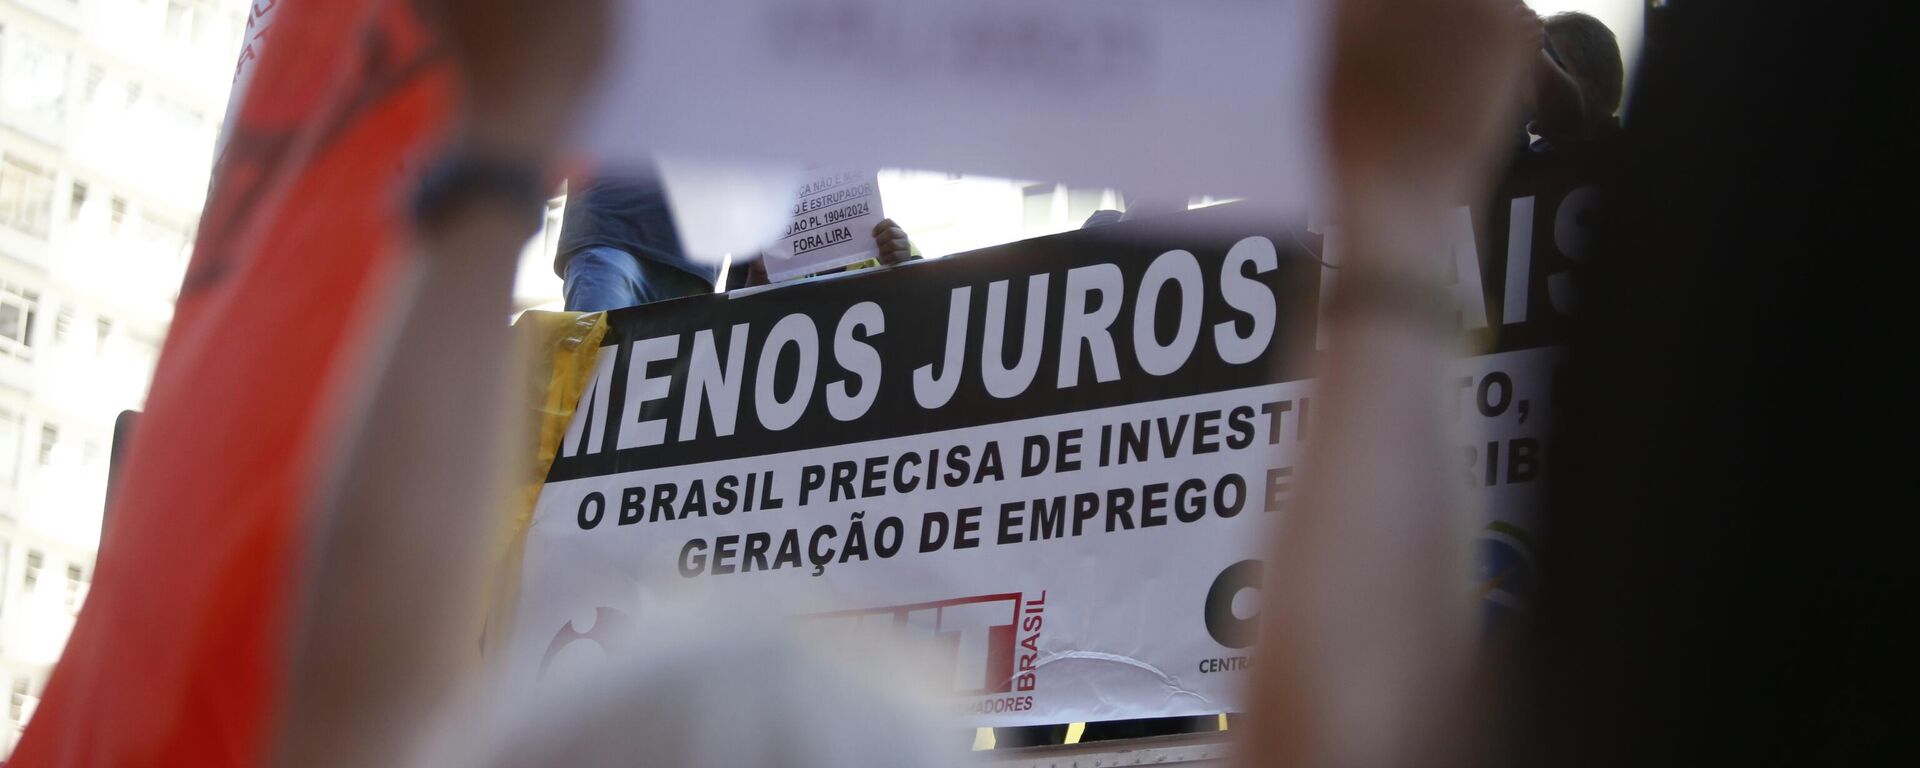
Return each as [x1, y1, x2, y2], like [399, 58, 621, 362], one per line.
[580, 0, 1327, 204]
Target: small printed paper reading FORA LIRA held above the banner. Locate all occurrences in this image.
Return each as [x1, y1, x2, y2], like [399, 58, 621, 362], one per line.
[762, 167, 887, 282]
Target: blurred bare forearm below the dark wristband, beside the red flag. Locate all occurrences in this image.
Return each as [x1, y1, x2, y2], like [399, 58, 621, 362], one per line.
[278, 198, 538, 766]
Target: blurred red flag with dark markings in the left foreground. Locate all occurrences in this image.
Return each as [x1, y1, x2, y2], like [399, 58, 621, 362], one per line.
[13, 0, 453, 766]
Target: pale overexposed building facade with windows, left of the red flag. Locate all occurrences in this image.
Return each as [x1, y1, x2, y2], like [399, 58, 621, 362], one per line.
[0, 0, 247, 760]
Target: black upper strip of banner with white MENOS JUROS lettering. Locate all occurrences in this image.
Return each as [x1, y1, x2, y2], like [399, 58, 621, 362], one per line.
[549, 157, 1597, 482]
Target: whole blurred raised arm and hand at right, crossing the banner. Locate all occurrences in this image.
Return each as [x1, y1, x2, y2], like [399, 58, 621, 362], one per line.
[1240, 0, 1538, 768]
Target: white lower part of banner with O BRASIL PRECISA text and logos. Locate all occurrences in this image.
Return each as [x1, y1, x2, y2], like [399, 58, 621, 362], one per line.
[507, 349, 1555, 726]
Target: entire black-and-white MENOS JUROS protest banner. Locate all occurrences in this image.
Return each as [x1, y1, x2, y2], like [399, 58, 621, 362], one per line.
[505, 157, 1592, 726]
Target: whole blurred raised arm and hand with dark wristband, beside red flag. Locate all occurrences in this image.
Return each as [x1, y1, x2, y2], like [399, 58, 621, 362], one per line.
[275, 0, 609, 766]
